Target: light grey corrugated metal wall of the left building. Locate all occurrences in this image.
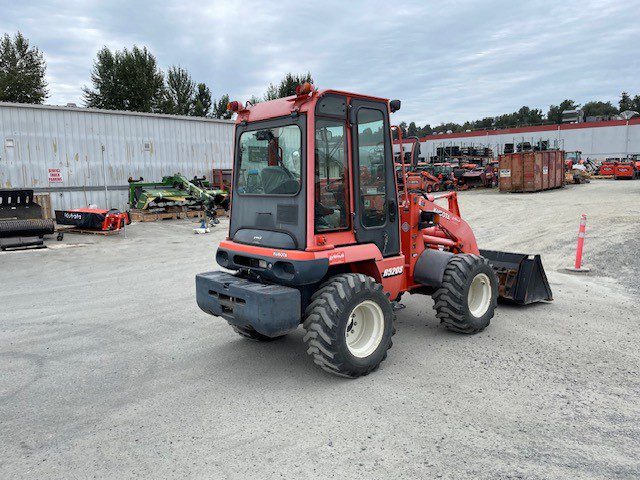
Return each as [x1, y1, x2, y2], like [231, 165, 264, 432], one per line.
[0, 103, 233, 209]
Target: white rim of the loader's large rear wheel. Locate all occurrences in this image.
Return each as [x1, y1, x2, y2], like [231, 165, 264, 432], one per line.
[344, 300, 384, 358]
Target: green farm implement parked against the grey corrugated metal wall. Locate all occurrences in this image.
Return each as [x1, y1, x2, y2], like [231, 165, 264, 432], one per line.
[129, 173, 229, 219]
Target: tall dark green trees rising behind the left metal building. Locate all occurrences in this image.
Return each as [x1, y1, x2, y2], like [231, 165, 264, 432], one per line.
[0, 32, 313, 119]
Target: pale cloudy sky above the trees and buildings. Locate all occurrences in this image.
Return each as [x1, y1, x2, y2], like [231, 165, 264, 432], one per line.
[0, 0, 640, 126]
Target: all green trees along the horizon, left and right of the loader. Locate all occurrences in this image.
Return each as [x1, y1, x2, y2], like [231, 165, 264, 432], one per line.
[0, 32, 640, 129]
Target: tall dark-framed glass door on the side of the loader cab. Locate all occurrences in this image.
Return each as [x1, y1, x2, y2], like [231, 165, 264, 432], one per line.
[349, 100, 400, 257]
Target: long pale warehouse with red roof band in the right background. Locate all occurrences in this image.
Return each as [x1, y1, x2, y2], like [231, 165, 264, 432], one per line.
[396, 118, 640, 160]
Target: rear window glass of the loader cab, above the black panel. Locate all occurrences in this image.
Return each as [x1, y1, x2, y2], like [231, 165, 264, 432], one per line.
[237, 125, 302, 195]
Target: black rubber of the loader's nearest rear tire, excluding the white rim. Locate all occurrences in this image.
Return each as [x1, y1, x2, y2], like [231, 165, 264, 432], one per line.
[304, 273, 395, 378]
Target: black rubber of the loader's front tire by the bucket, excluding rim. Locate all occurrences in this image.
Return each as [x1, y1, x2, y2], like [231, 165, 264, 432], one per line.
[433, 254, 498, 334]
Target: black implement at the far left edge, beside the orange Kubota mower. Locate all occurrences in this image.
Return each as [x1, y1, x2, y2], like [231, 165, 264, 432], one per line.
[0, 189, 55, 250]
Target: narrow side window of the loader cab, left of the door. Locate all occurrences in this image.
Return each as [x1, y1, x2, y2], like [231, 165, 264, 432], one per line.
[315, 117, 349, 232]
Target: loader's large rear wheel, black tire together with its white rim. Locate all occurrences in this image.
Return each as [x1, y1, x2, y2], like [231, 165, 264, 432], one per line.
[304, 273, 395, 378]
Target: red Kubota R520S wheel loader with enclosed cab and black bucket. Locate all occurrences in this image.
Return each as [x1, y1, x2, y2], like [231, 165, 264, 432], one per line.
[196, 83, 552, 378]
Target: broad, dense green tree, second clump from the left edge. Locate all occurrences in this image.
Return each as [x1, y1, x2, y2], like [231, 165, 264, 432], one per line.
[82, 46, 166, 112]
